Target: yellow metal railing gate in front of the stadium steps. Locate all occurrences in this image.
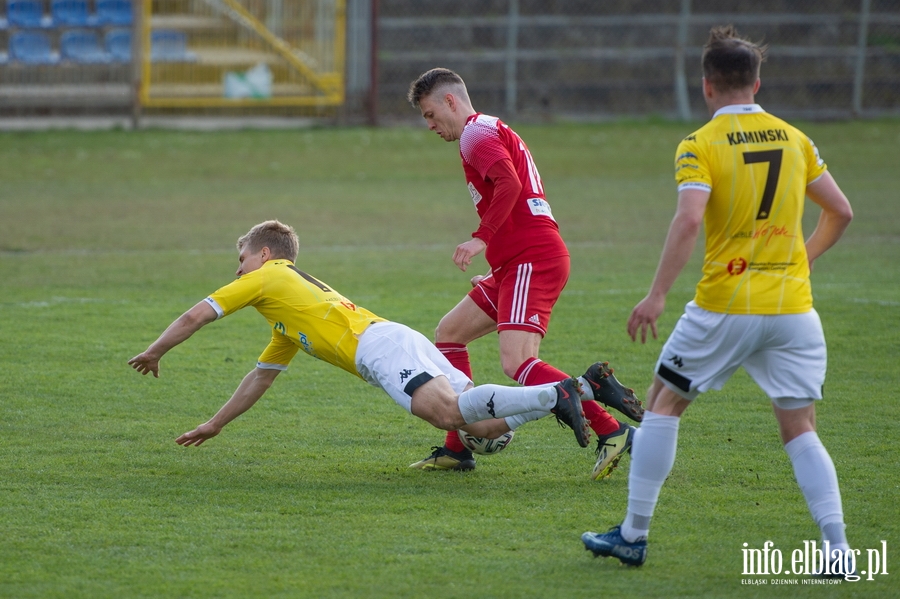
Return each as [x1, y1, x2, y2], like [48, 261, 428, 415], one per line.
[136, 0, 346, 108]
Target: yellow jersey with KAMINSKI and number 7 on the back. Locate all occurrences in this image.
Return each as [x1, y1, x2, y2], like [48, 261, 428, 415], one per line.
[675, 104, 826, 314]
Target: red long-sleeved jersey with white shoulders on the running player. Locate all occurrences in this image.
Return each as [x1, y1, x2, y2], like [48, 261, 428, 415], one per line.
[459, 114, 569, 269]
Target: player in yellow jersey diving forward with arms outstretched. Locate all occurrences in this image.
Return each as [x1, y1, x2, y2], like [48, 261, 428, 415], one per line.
[128, 221, 590, 454]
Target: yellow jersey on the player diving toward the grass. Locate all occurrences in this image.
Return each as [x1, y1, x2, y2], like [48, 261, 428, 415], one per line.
[206, 260, 385, 376]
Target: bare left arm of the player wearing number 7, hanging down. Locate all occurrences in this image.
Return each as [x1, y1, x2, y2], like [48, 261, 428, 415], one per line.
[628, 189, 709, 343]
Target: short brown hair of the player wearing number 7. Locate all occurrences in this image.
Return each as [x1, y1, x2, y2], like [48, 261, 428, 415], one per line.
[701, 25, 767, 92]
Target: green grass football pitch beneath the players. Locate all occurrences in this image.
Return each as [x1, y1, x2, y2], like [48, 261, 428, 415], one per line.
[0, 121, 900, 599]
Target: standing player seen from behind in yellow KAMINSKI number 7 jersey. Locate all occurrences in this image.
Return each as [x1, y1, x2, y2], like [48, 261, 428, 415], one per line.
[582, 26, 853, 576]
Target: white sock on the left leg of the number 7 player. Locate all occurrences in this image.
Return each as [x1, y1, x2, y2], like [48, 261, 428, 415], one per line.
[621, 412, 681, 543]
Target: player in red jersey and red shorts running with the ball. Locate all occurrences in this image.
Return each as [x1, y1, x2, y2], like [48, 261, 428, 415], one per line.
[407, 68, 643, 479]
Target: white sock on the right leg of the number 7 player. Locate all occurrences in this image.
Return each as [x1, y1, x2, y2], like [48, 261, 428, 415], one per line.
[784, 431, 849, 548]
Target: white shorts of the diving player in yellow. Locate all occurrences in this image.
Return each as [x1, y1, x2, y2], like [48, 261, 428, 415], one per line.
[356, 322, 472, 412]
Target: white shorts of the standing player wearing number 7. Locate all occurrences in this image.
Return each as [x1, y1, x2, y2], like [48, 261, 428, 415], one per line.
[656, 301, 827, 400]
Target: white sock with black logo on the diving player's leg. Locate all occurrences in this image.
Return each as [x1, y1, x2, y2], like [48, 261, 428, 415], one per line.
[459, 384, 556, 428]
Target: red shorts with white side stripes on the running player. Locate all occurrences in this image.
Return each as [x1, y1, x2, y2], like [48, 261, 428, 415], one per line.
[469, 256, 569, 337]
